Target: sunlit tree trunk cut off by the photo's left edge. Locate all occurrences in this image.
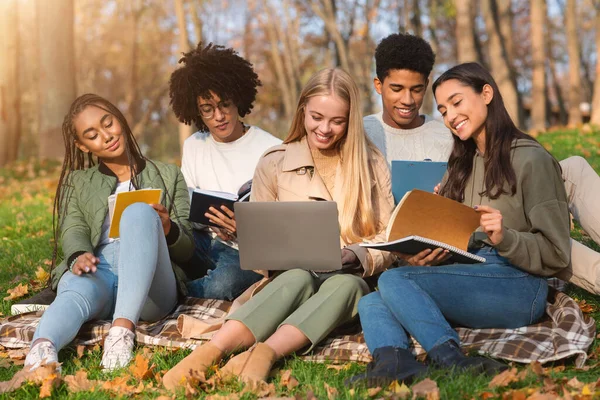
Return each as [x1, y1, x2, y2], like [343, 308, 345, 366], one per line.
[0, 0, 21, 167]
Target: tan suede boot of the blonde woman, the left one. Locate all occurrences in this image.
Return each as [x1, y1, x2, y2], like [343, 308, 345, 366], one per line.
[163, 342, 223, 390]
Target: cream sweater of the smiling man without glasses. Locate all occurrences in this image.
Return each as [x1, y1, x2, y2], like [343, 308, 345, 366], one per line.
[363, 112, 453, 165]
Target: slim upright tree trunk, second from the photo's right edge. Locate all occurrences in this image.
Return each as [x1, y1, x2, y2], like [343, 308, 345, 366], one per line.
[565, 0, 581, 127]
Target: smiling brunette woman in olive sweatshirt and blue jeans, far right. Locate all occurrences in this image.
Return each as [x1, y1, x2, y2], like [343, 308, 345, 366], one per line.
[355, 63, 571, 385]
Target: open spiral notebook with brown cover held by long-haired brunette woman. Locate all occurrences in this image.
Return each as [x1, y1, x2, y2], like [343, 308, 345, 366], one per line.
[361, 190, 485, 264]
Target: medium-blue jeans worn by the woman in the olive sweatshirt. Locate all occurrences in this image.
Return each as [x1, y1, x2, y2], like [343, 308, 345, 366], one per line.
[358, 247, 548, 352]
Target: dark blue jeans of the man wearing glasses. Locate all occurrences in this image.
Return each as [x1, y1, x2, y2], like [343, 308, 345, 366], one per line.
[187, 229, 262, 301]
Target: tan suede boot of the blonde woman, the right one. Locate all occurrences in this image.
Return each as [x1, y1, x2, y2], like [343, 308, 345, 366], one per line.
[221, 343, 277, 382]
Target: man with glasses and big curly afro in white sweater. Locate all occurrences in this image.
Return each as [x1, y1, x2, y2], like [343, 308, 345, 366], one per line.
[169, 43, 281, 300]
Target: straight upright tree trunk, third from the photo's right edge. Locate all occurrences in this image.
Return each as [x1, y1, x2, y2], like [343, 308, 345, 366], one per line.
[531, 0, 546, 133]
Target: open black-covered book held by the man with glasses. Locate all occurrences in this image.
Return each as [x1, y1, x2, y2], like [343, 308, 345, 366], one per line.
[190, 181, 252, 227]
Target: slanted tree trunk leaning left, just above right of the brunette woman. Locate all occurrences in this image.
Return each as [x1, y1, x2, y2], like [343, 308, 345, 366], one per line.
[481, 0, 523, 126]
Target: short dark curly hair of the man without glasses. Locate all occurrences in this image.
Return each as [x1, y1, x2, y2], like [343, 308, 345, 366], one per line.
[375, 33, 435, 82]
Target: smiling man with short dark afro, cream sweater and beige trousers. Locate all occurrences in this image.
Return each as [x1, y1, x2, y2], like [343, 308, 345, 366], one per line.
[364, 34, 600, 294]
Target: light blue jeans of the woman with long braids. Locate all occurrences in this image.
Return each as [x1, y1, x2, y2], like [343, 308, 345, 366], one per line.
[33, 203, 178, 350]
